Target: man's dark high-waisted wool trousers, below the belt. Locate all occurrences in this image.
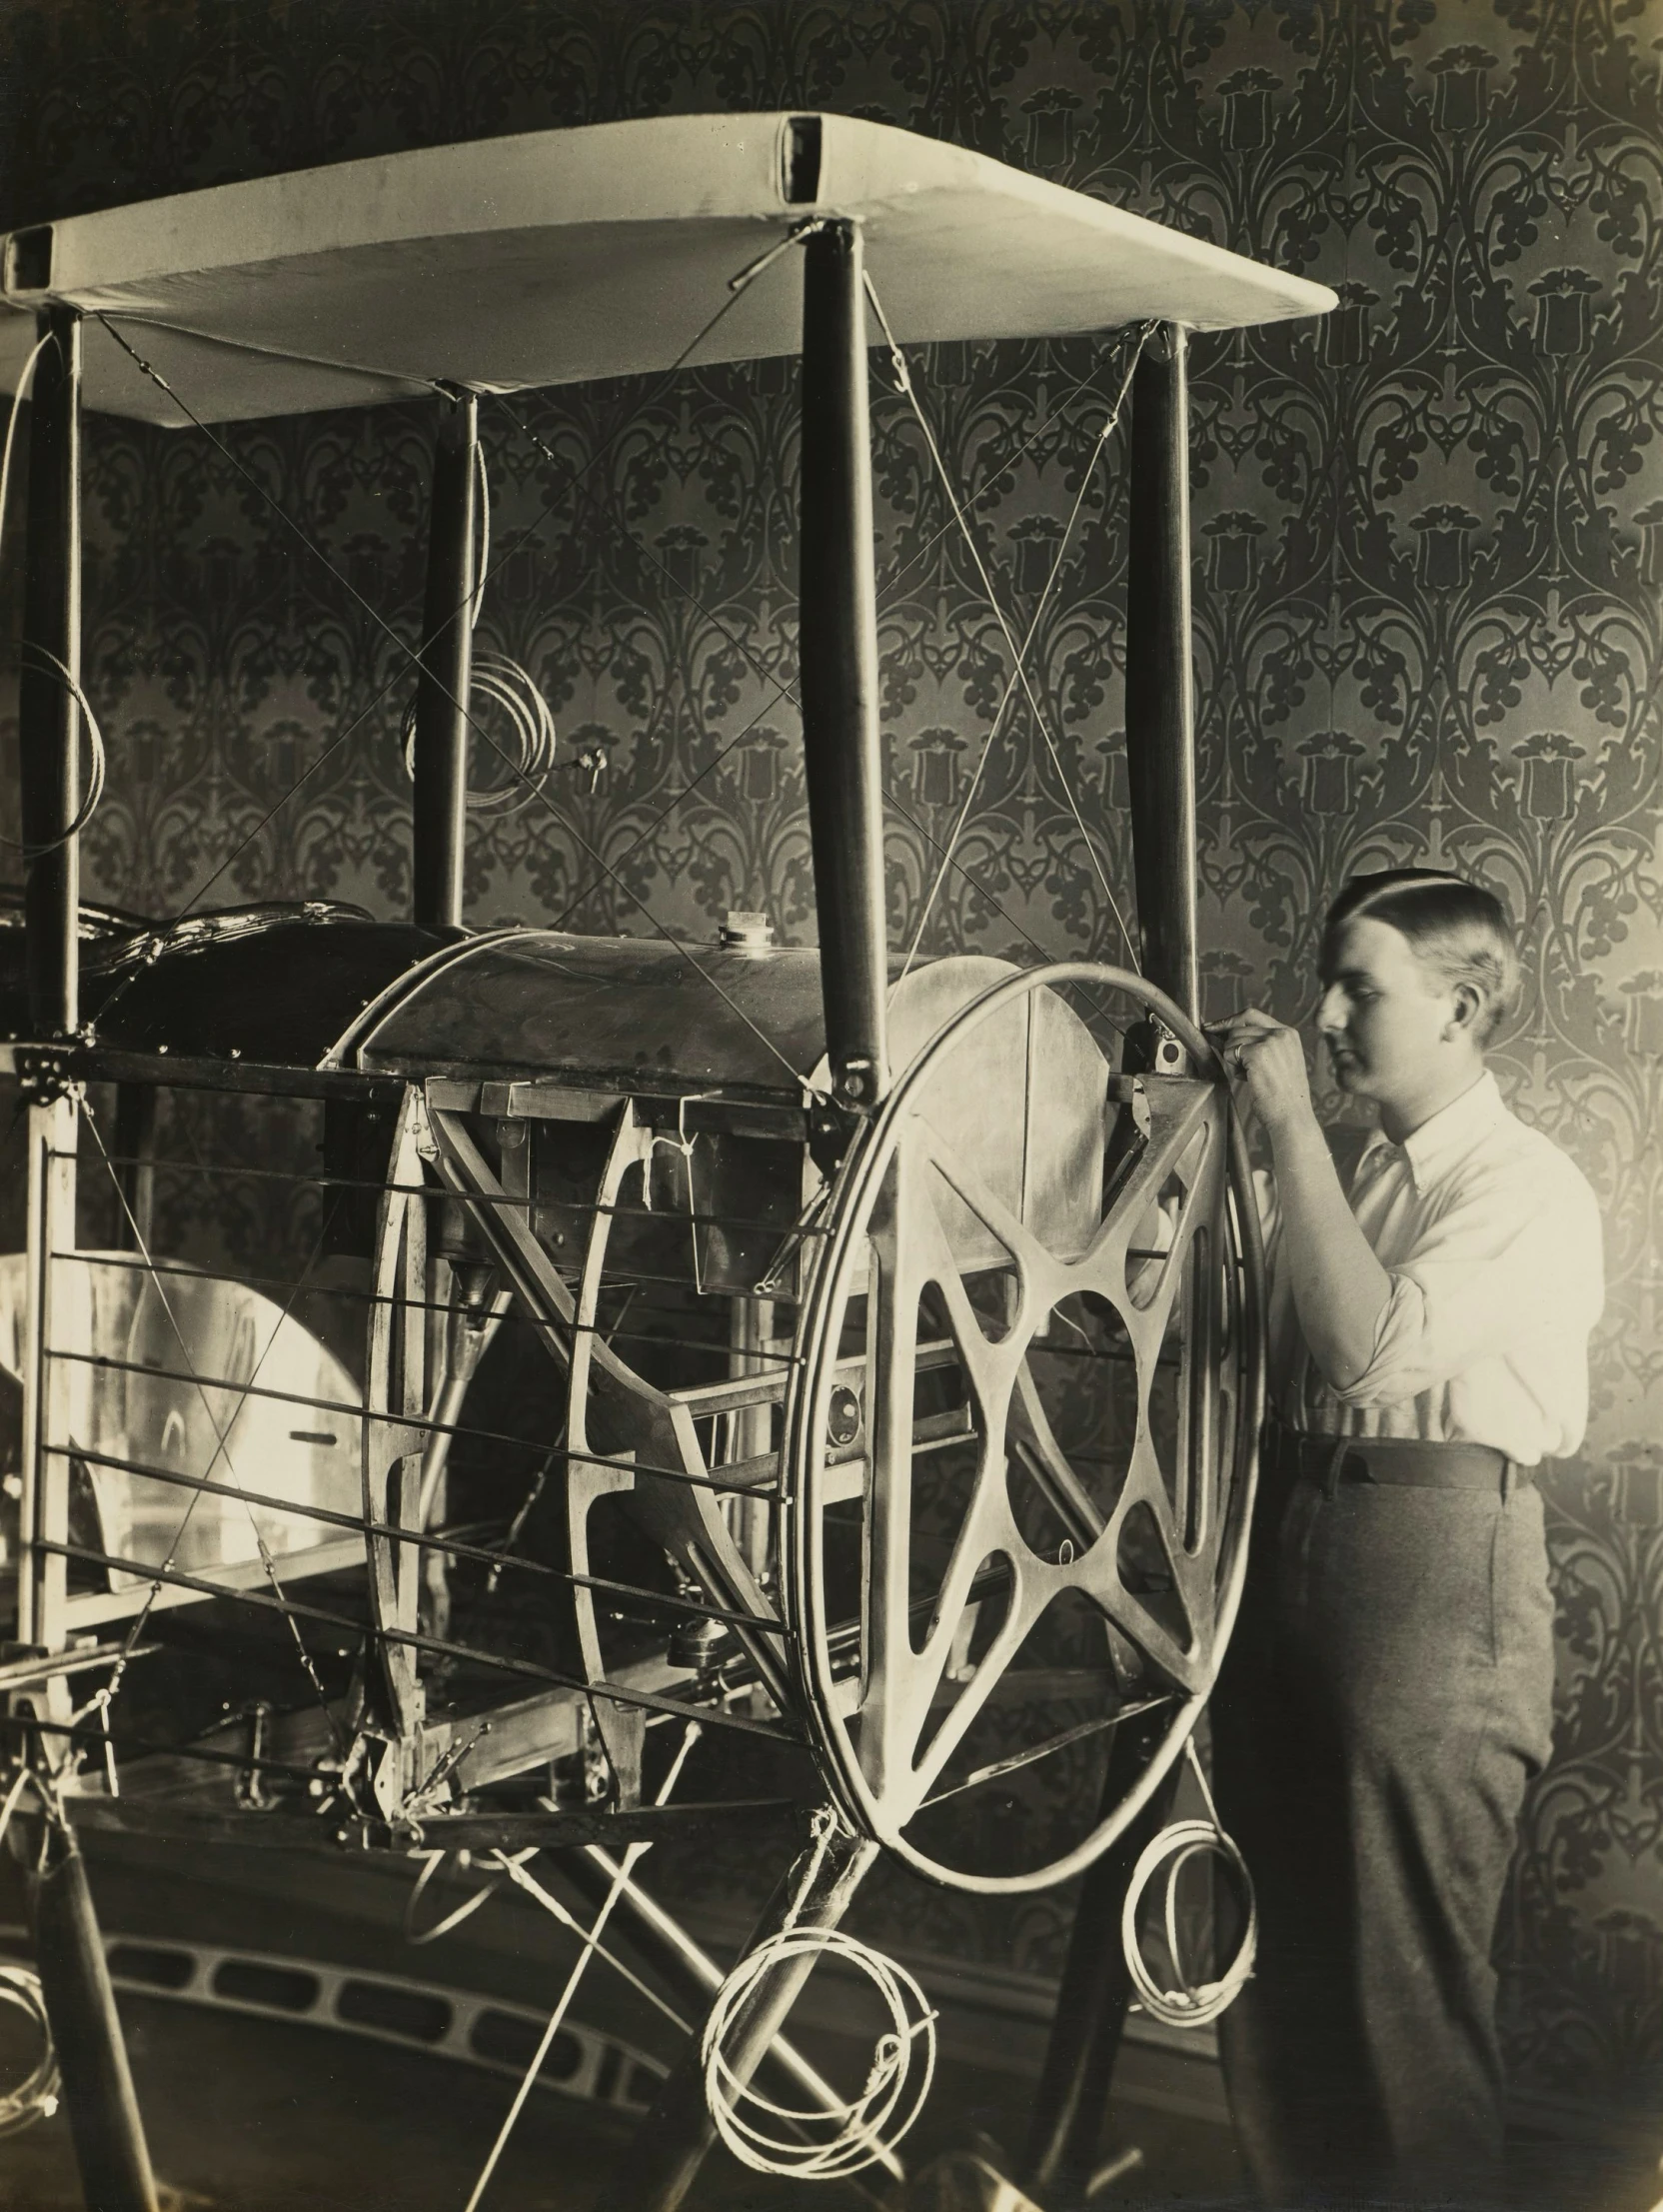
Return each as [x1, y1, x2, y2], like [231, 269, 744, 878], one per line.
[1212, 1466, 1552, 2212]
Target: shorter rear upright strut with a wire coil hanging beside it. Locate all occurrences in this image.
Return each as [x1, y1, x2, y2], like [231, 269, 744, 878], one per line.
[412, 392, 480, 929]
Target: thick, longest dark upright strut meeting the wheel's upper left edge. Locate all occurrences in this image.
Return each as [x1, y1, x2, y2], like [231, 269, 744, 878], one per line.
[799, 224, 889, 1108]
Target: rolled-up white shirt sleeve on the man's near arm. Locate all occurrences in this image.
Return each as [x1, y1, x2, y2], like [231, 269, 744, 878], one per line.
[1329, 1170, 1603, 1406]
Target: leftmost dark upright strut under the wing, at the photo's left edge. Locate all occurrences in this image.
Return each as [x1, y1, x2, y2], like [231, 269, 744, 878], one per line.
[18, 305, 82, 1040]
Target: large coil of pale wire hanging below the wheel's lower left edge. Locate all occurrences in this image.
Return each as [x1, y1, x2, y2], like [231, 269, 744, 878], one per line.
[699, 1814, 935, 2181]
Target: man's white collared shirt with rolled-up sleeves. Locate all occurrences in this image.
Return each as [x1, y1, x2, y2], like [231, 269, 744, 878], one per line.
[1258, 1073, 1605, 1466]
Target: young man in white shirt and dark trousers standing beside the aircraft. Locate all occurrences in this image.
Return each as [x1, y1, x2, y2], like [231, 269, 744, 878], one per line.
[1214, 870, 1601, 2208]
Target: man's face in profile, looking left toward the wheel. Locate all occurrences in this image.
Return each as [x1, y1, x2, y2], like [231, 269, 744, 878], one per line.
[1316, 916, 1455, 1104]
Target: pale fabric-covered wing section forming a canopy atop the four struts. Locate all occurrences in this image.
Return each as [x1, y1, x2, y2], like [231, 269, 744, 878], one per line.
[0, 115, 1333, 427]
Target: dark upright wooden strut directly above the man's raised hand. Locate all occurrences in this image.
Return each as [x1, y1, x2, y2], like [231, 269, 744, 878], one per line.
[1125, 323, 1201, 1020]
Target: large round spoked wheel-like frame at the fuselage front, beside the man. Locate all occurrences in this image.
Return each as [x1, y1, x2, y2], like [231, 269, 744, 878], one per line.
[786, 963, 1262, 1891]
